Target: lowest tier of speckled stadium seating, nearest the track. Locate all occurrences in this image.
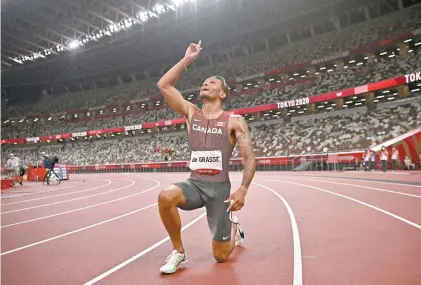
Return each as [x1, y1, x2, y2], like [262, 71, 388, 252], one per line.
[2, 98, 421, 165]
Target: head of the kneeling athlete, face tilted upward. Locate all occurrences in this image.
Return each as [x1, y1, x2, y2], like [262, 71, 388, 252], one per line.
[199, 75, 229, 102]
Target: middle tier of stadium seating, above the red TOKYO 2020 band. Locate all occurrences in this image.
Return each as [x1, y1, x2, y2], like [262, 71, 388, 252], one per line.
[3, 35, 421, 138]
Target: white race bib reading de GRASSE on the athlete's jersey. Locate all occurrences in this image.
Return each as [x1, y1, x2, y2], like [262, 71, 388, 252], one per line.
[189, 150, 222, 175]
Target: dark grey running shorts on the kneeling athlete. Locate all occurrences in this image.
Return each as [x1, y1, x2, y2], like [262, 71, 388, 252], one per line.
[174, 177, 232, 242]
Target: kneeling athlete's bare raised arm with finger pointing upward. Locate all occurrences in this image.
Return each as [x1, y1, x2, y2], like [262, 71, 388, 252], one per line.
[157, 41, 202, 119]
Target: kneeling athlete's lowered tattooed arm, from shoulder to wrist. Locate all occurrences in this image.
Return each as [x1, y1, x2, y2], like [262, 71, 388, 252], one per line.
[234, 116, 256, 189]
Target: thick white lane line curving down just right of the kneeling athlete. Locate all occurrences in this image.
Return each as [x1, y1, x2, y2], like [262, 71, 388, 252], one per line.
[238, 179, 303, 285]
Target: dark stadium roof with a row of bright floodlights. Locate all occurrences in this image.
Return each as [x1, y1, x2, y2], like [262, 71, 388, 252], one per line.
[1, 0, 366, 87]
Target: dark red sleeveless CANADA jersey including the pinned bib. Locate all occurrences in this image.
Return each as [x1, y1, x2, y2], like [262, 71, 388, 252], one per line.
[188, 110, 234, 182]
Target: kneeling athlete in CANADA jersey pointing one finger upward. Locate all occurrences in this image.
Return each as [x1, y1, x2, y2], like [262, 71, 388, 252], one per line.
[157, 41, 256, 274]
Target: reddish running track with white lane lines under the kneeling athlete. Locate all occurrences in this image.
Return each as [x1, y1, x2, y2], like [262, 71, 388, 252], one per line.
[1, 172, 421, 285]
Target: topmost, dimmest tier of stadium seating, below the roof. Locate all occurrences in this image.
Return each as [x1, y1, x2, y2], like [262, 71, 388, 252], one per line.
[4, 4, 421, 116]
